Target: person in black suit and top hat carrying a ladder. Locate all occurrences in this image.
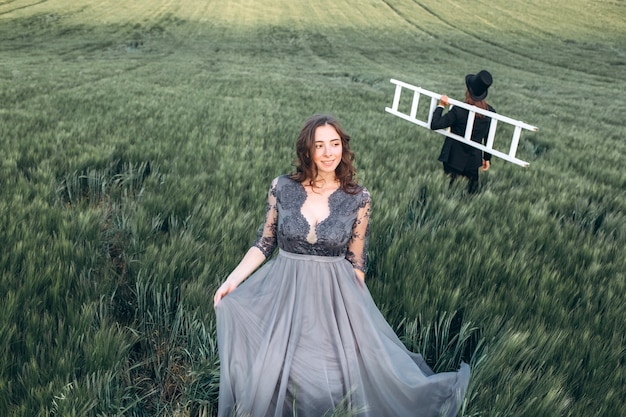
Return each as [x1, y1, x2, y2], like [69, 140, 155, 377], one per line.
[430, 70, 495, 193]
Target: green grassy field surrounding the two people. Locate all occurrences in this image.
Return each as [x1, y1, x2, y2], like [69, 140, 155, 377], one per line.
[0, 0, 626, 417]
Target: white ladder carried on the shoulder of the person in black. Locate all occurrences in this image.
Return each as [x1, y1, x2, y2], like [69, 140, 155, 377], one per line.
[385, 79, 537, 167]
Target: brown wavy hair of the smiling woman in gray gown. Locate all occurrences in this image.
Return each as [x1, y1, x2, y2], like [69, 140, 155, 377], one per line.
[289, 114, 361, 194]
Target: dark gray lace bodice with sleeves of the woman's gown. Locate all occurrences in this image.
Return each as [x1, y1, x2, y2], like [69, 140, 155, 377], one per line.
[254, 175, 371, 272]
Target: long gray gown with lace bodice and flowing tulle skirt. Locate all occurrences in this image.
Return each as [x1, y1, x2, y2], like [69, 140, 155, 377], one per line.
[215, 176, 470, 417]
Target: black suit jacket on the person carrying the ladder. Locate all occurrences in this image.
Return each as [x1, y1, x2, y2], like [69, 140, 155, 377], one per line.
[430, 106, 495, 172]
